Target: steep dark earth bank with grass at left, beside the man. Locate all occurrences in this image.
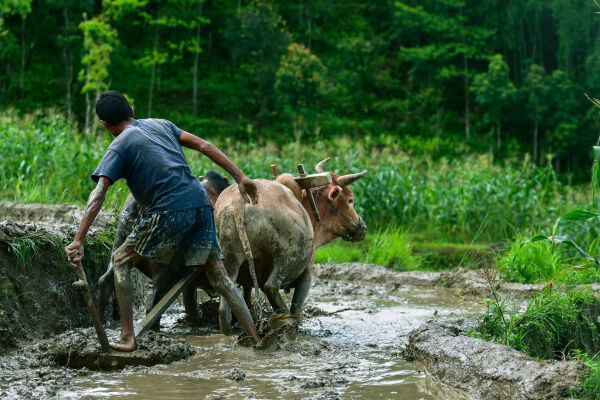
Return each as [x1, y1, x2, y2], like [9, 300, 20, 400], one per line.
[0, 219, 146, 354]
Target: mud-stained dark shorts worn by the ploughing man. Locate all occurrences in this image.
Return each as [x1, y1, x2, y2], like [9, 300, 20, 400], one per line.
[125, 206, 223, 265]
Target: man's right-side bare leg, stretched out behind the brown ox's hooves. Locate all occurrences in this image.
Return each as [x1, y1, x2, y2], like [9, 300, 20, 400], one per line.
[204, 259, 260, 342]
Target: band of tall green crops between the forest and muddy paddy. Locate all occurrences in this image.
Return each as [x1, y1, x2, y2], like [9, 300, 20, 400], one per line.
[0, 112, 584, 244]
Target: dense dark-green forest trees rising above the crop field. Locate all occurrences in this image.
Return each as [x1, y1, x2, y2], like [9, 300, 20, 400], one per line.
[0, 0, 600, 178]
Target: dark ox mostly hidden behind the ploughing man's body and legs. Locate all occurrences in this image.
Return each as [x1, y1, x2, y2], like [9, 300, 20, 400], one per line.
[98, 171, 229, 328]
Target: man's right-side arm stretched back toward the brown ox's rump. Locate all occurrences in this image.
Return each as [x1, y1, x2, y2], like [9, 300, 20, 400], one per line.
[179, 131, 258, 204]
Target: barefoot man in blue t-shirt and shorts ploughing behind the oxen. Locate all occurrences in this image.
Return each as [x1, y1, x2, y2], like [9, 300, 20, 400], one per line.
[65, 91, 259, 351]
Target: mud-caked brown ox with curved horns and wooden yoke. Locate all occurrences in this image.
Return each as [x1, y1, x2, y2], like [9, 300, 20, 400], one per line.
[215, 158, 367, 333]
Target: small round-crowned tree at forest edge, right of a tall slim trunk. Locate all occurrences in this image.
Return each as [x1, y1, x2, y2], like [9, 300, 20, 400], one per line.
[471, 54, 516, 152]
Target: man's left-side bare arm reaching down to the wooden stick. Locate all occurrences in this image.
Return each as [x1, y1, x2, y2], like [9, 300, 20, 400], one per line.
[65, 176, 113, 265]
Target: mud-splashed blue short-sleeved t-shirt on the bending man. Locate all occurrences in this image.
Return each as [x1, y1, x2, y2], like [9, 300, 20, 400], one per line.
[92, 118, 212, 213]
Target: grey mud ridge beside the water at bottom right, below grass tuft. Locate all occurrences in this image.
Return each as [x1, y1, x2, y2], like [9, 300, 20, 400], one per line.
[407, 320, 589, 400]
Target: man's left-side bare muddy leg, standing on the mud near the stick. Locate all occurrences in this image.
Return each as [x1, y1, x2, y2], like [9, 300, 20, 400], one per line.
[110, 244, 142, 351]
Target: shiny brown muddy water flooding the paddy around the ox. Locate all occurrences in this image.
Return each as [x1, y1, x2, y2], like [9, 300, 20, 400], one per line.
[57, 280, 481, 400]
